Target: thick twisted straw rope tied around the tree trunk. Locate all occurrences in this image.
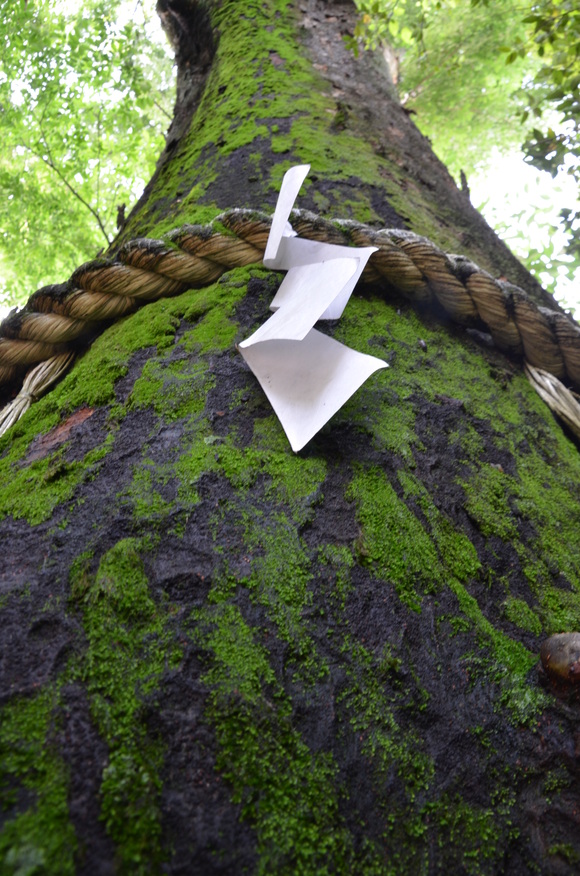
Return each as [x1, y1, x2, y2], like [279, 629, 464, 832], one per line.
[0, 210, 580, 438]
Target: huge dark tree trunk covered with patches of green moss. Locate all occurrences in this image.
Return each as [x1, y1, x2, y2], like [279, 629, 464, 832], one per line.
[0, 0, 580, 876]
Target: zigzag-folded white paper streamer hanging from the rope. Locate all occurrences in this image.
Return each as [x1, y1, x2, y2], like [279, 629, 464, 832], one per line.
[238, 165, 388, 451]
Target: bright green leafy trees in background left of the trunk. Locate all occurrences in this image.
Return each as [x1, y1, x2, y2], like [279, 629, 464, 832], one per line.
[0, 0, 174, 303]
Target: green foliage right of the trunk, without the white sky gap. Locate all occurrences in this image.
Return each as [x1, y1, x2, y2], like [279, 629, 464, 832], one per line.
[351, 0, 580, 296]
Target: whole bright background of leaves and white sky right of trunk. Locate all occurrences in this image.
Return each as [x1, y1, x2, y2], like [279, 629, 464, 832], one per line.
[351, 0, 580, 307]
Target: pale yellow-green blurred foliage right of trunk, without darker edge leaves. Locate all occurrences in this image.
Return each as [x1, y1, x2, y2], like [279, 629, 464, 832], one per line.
[354, 0, 539, 178]
